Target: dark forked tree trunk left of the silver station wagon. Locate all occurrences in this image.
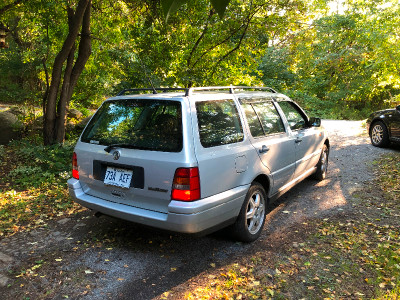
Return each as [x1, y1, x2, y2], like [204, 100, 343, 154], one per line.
[43, 0, 91, 145]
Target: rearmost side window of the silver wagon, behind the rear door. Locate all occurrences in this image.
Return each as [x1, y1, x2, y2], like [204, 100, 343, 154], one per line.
[196, 100, 243, 148]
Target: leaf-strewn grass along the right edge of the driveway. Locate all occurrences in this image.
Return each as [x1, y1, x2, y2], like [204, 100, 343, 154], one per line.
[175, 154, 400, 299]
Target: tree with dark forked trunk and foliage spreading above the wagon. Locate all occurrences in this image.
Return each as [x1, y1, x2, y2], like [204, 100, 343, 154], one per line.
[0, 0, 305, 144]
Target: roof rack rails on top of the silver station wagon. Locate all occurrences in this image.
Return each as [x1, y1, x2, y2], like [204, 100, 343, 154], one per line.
[117, 85, 277, 97]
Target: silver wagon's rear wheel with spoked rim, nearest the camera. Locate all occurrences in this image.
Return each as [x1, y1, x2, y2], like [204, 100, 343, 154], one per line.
[232, 182, 267, 243]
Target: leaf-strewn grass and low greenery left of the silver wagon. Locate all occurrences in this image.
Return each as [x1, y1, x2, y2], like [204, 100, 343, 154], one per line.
[0, 137, 83, 237]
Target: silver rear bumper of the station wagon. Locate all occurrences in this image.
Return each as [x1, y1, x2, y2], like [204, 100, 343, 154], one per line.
[68, 178, 250, 233]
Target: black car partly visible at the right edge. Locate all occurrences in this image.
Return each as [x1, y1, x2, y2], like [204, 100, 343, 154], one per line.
[367, 105, 400, 147]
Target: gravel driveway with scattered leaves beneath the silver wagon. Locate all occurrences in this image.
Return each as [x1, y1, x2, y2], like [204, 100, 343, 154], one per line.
[0, 120, 400, 299]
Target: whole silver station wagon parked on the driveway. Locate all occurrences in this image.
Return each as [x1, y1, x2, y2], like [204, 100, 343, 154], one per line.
[68, 86, 329, 242]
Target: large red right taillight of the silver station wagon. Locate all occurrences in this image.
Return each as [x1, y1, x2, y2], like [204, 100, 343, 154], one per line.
[171, 167, 200, 201]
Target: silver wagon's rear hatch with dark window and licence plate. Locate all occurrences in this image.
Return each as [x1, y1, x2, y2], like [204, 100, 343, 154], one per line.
[75, 98, 196, 213]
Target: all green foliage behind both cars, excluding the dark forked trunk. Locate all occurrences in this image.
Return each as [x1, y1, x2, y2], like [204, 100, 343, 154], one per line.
[0, 0, 400, 119]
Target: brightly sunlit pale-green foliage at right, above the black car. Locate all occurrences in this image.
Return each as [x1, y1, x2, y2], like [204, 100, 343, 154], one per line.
[259, 0, 400, 119]
